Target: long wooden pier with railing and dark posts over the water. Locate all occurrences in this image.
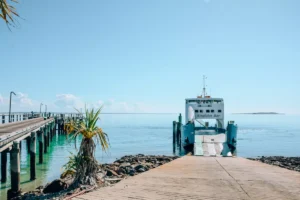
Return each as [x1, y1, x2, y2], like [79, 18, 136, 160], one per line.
[0, 114, 78, 199]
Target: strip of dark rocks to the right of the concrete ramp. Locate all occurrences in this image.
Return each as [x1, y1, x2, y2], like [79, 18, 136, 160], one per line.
[248, 156, 300, 172]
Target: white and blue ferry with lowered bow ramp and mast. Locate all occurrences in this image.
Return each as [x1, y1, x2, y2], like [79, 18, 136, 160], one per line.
[180, 76, 238, 156]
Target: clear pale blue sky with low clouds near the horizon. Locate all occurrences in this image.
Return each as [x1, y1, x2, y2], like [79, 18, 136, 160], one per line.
[0, 0, 300, 114]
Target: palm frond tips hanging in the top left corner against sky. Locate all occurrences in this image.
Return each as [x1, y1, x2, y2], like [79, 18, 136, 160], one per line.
[0, 0, 19, 25]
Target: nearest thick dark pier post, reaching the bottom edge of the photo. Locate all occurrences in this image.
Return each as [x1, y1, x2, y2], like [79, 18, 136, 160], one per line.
[7, 141, 21, 199]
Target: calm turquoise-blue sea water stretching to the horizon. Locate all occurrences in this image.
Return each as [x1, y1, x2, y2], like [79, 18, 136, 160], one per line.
[0, 114, 300, 199]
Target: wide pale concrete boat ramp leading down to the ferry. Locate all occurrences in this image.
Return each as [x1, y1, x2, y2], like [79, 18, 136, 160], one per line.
[73, 156, 300, 200]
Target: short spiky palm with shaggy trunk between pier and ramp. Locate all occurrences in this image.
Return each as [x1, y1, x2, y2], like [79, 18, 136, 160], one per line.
[66, 108, 109, 187]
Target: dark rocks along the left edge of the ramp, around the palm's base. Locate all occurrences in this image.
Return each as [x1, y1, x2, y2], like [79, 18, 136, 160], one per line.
[14, 154, 178, 200]
